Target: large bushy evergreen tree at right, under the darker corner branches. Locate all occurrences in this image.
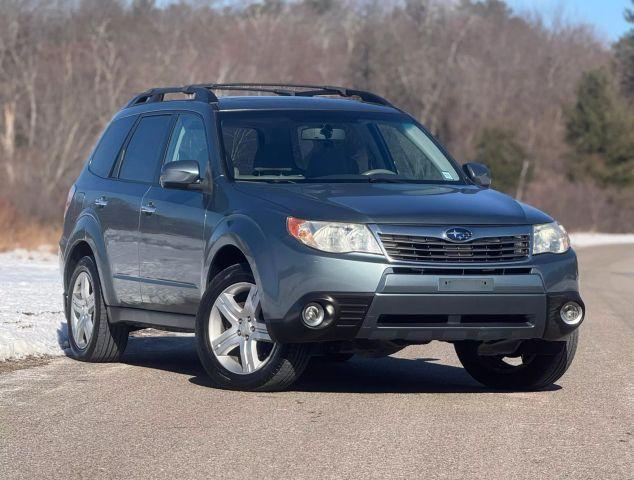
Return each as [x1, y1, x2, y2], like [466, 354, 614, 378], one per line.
[564, 70, 634, 186]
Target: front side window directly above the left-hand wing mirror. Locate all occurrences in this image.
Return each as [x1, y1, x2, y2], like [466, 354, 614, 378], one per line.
[165, 113, 209, 177]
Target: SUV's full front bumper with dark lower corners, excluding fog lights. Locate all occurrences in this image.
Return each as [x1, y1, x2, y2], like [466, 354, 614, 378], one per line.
[267, 242, 585, 343]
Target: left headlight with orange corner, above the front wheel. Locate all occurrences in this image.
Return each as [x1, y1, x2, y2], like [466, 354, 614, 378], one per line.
[286, 217, 382, 254]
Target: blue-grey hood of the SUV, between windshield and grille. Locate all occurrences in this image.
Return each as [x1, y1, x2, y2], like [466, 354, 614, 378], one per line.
[235, 182, 552, 225]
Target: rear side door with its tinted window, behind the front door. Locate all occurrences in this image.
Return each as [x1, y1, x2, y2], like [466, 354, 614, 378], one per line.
[107, 114, 172, 306]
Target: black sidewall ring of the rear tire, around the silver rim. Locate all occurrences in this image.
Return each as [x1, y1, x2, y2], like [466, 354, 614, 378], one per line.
[66, 257, 103, 359]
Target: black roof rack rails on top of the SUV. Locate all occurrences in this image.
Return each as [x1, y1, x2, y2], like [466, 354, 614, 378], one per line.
[125, 83, 393, 108]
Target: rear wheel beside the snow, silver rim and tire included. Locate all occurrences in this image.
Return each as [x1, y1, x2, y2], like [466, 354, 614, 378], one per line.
[66, 257, 128, 362]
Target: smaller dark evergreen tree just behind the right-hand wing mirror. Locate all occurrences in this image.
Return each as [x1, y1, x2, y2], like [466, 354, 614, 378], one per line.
[474, 127, 527, 195]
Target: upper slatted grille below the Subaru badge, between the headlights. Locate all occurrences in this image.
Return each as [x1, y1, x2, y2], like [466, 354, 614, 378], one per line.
[379, 233, 529, 263]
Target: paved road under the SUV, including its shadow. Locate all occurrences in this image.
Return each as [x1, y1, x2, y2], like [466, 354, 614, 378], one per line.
[0, 246, 634, 479]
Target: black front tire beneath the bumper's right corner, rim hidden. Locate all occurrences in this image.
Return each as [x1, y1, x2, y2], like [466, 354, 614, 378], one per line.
[455, 330, 579, 390]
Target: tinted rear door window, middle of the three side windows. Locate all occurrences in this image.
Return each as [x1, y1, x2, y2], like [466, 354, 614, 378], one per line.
[119, 115, 172, 183]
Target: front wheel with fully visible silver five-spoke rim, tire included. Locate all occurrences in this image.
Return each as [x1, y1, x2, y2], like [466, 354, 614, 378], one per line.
[196, 264, 310, 391]
